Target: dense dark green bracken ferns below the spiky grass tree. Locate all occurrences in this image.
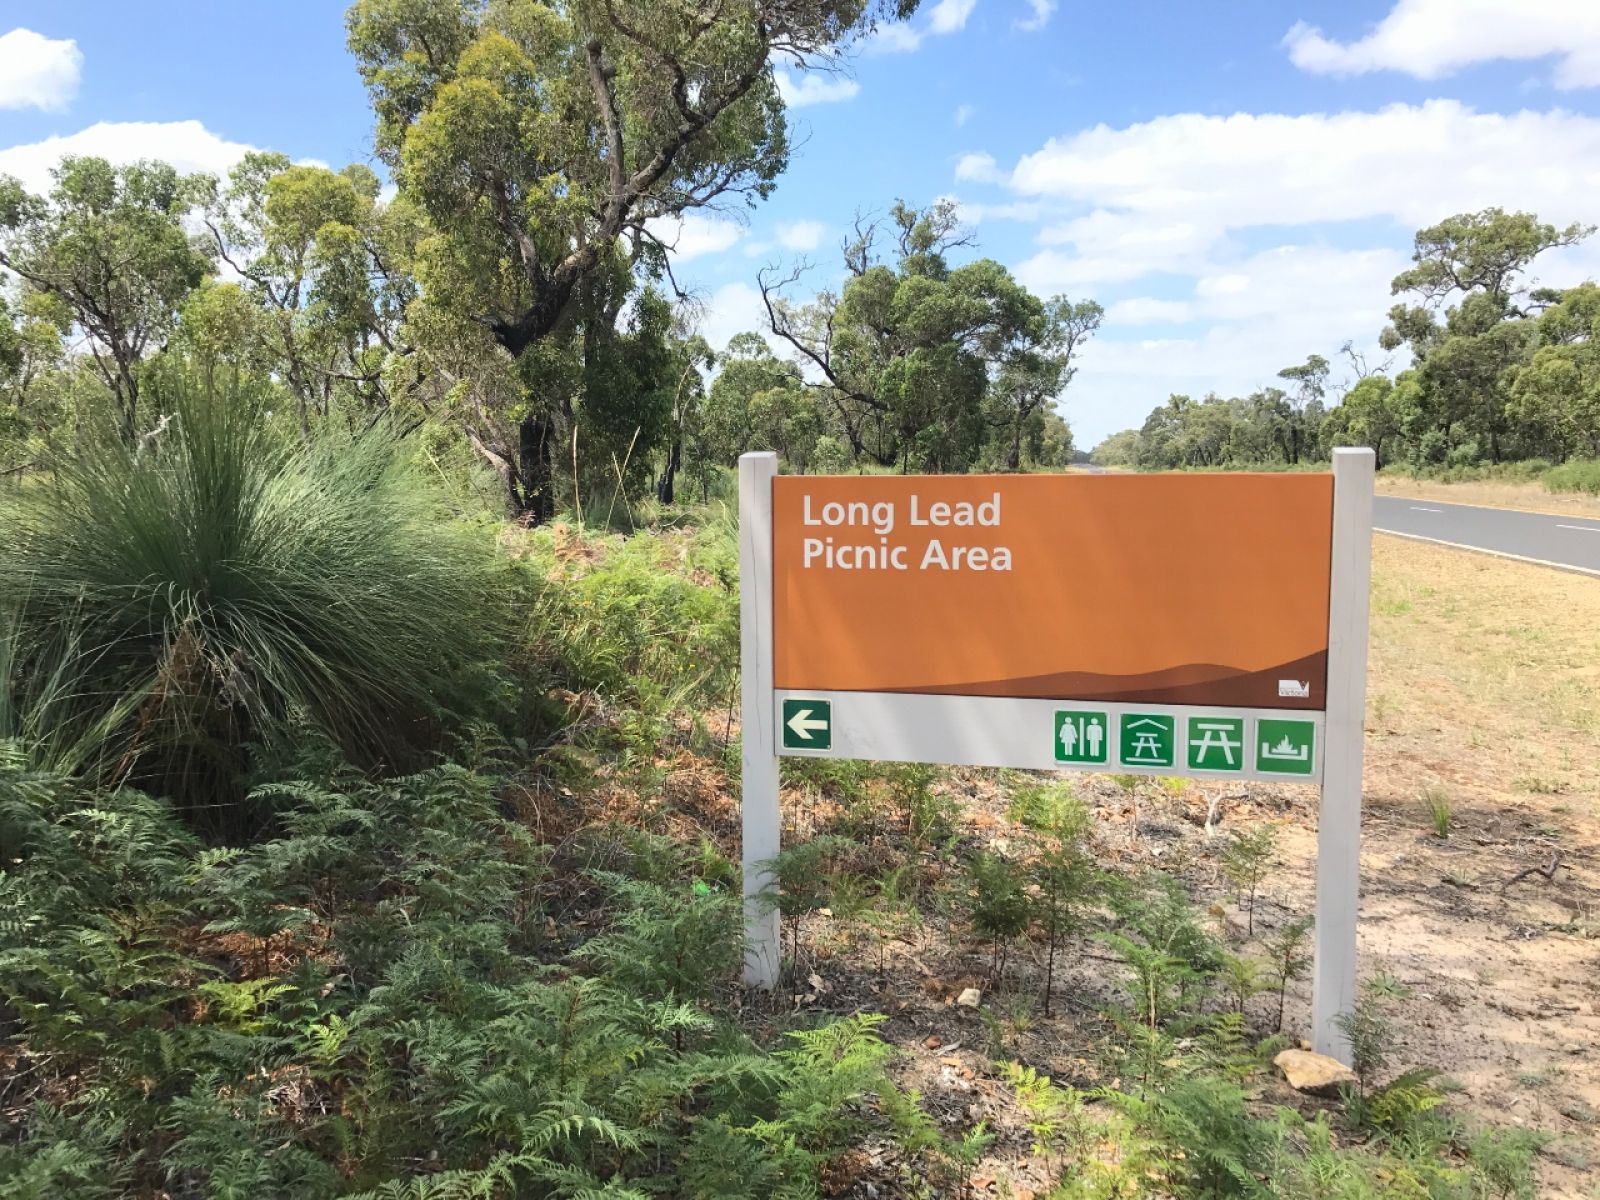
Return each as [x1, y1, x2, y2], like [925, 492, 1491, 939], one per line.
[0, 755, 938, 1200]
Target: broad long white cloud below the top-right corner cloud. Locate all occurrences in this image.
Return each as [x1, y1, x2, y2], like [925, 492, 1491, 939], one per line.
[1011, 101, 1600, 278]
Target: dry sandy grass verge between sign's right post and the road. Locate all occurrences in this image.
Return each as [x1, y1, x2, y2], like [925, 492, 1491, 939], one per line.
[1350, 534, 1600, 1200]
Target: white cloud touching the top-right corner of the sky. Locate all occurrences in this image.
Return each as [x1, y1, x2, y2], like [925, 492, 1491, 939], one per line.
[1283, 0, 1600, 88]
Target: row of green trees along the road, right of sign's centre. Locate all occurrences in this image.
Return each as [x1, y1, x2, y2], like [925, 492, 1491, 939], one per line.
[1096, 208, 1600, 467]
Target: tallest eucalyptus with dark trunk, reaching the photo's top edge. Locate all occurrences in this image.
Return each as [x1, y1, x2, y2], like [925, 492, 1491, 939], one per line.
[347, 0, 915, 518]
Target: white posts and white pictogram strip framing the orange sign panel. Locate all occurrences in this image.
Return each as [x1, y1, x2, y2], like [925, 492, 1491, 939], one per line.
[739, 450, 1374, 1059]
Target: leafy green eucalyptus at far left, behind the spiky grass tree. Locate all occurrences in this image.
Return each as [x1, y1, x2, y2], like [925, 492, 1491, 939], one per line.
[0, 157, 213, 442]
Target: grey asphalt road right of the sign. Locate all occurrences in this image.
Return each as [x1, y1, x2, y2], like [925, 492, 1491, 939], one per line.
[1373, 496, 1600, 574]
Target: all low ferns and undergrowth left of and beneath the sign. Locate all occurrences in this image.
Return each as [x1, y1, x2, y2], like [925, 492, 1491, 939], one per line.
[0, 473, 1538, 1198]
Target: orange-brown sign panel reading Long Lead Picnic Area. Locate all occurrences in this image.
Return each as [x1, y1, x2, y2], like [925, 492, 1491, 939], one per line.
[773, 474, 1333, 709]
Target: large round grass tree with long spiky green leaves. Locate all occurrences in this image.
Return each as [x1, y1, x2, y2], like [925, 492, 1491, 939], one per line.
[0, 390, 493, 838]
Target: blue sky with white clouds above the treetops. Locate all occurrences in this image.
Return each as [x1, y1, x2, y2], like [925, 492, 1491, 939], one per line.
[0, 0, 1600, 446]
